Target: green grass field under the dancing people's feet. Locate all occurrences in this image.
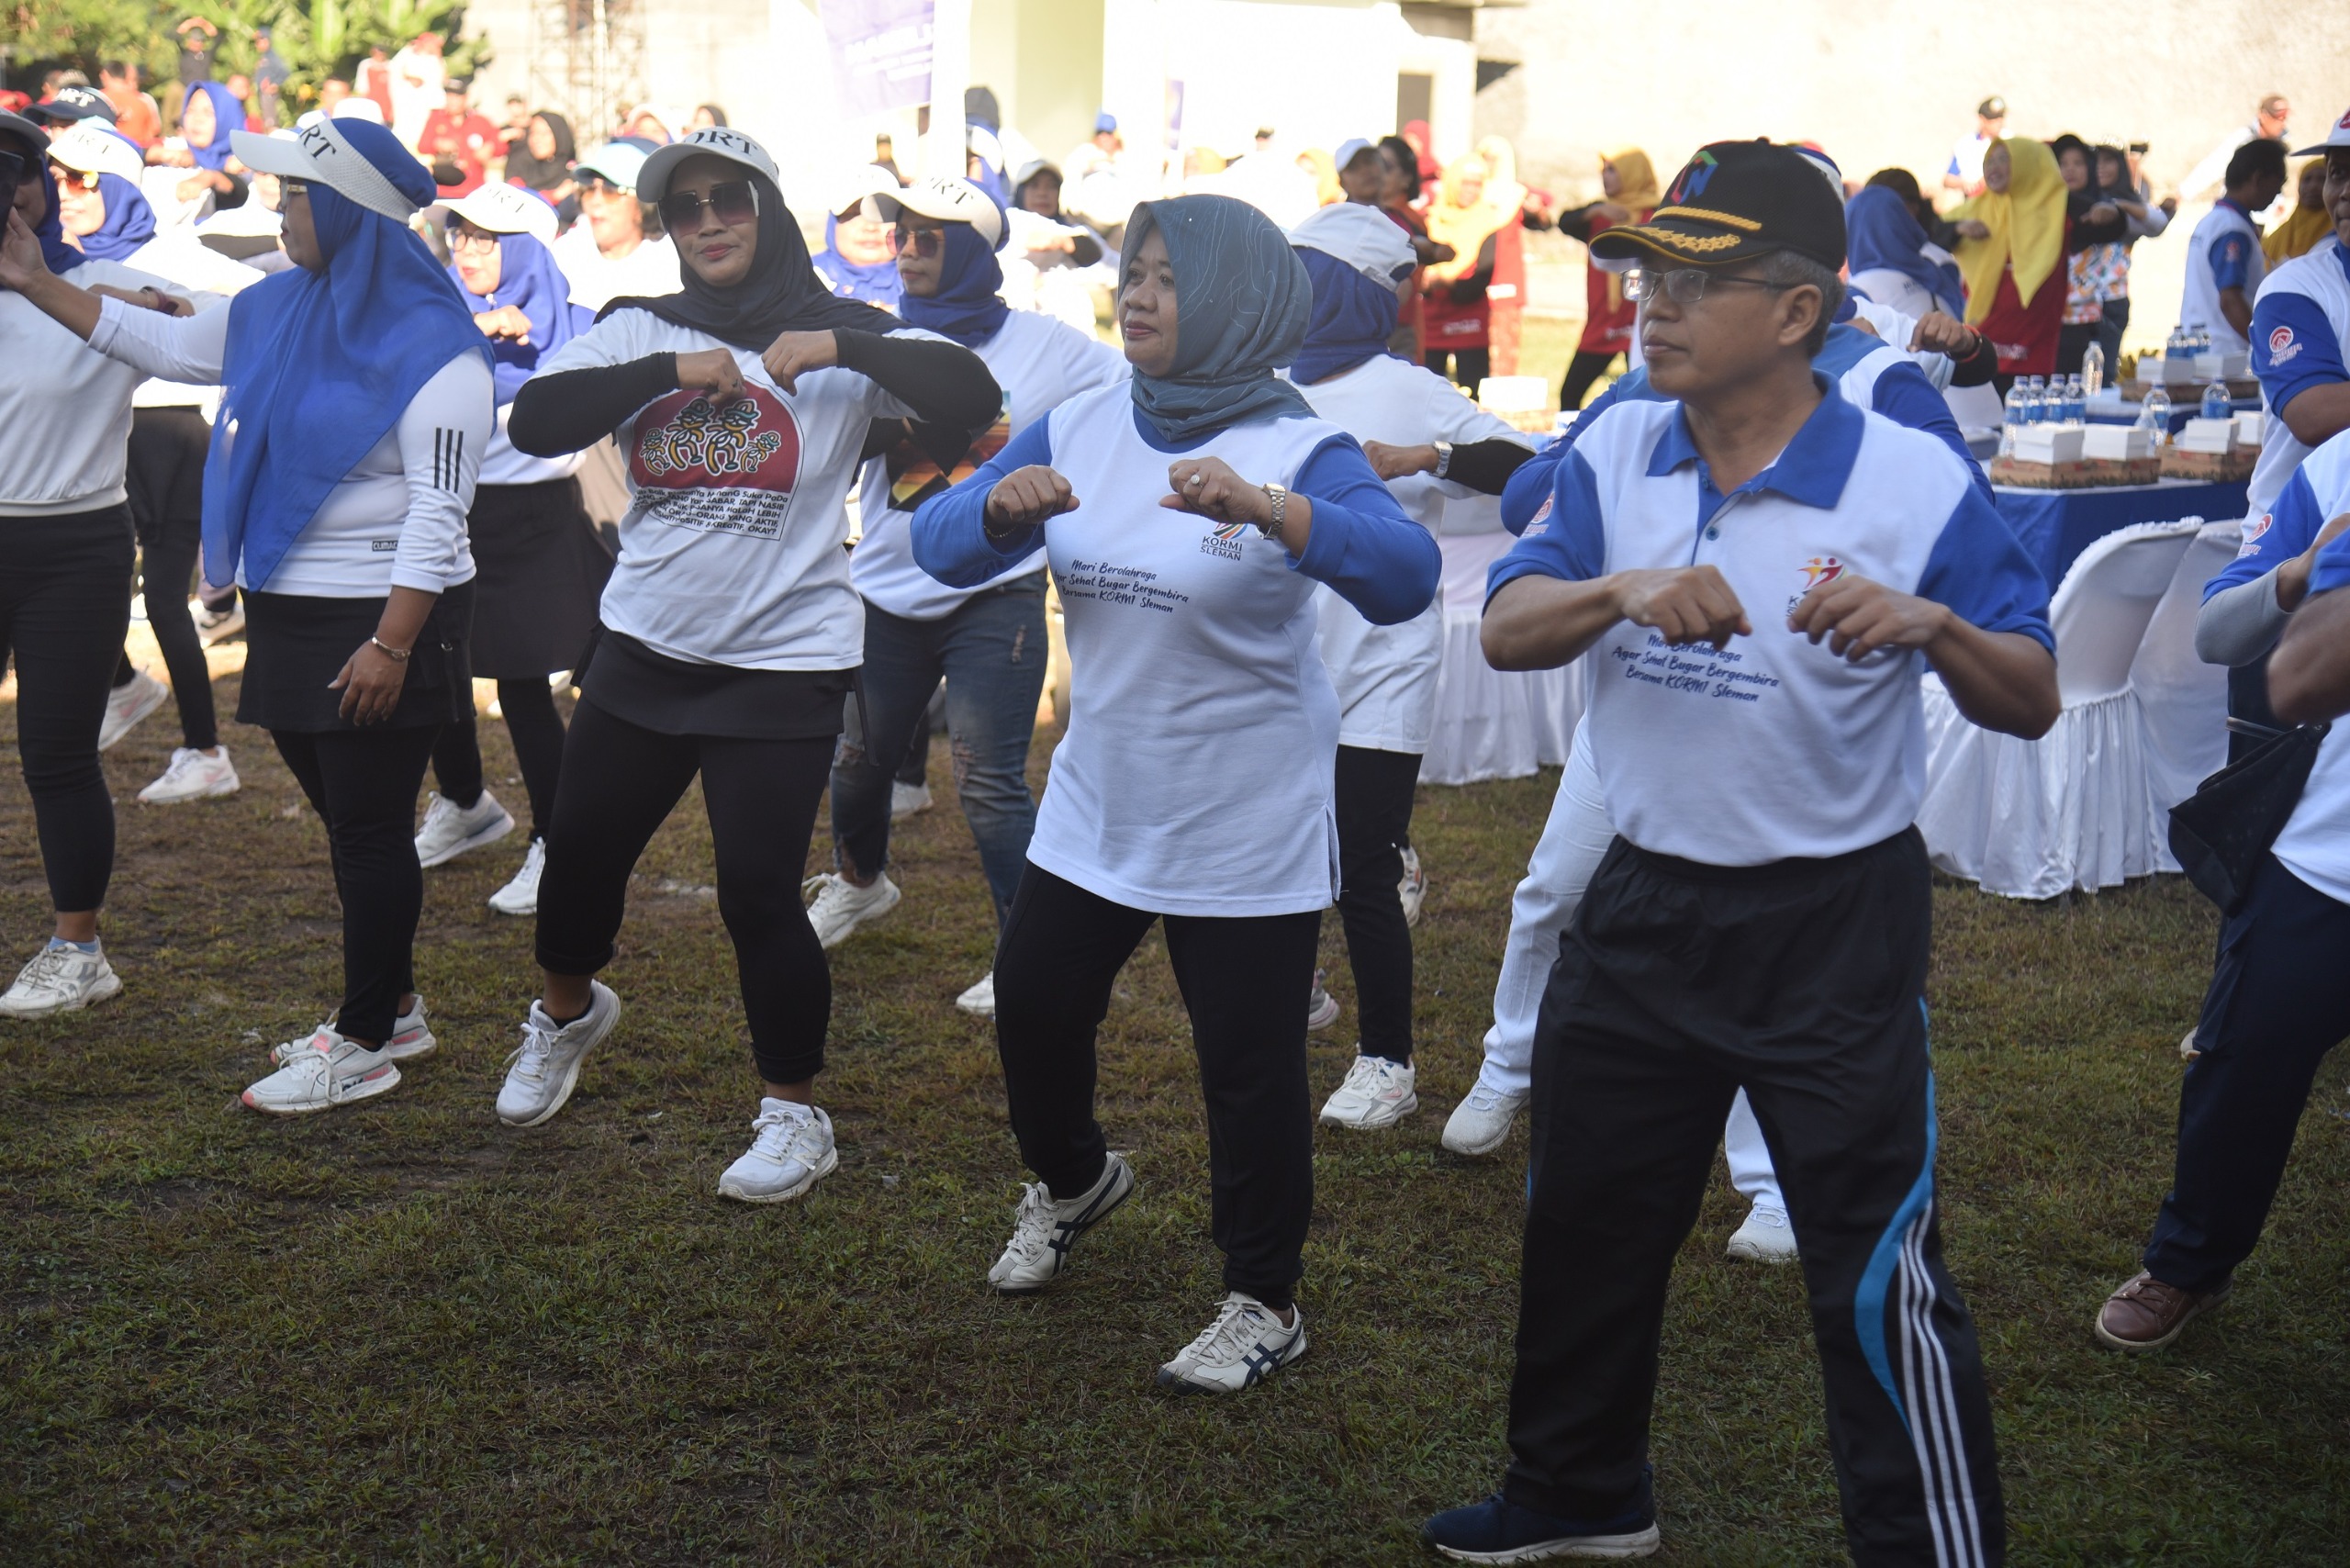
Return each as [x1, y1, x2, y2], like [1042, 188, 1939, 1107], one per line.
[0, 679, 2350, 1565]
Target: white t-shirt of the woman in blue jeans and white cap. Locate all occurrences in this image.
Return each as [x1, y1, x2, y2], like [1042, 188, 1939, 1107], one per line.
[848, 310, 1130, 621]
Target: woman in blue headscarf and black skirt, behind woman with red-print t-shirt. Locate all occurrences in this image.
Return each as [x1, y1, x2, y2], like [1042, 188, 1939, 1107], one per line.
[416, 185, 611, 914]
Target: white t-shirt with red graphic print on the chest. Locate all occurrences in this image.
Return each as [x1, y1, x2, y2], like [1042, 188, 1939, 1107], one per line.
[538, 310, 931, 670]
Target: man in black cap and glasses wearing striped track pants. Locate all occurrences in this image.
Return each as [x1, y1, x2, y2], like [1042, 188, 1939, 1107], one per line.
[1427, 141, 2059, 1568]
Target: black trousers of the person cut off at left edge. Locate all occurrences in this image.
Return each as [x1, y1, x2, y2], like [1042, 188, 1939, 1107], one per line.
[0, 506, 131, 914]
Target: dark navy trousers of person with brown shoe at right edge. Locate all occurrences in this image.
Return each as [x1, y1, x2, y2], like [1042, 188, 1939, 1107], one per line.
[2143, 856, 2350, 1291]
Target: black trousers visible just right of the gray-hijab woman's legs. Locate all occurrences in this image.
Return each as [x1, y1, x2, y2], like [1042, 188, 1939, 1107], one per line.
[1337, 745, 1419, 1068]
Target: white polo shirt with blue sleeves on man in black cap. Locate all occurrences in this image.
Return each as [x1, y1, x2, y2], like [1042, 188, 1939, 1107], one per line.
[1487, 372, 2056, 865]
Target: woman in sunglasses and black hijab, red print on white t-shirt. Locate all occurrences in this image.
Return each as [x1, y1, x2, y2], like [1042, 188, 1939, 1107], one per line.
[498, 127, 1002, 1204]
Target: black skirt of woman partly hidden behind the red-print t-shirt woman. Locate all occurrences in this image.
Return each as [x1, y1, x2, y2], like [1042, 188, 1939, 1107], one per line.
[465, 479, 611, 679]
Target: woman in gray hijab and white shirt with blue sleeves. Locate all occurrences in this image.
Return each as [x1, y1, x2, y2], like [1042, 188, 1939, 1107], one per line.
[914, 196, 1440, 1392]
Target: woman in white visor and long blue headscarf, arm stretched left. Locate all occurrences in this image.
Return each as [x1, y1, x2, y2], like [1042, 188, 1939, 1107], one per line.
[0, 120, 494, 1114]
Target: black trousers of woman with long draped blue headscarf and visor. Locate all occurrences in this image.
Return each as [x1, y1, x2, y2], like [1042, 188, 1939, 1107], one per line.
[270, 724, 437, 1044]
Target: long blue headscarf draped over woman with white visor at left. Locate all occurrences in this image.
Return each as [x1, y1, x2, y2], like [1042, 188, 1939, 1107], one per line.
[205, 120, 488, 588]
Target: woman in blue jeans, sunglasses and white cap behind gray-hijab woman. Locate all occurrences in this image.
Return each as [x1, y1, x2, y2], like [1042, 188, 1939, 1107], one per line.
[809, 179, 1125, 1015]
